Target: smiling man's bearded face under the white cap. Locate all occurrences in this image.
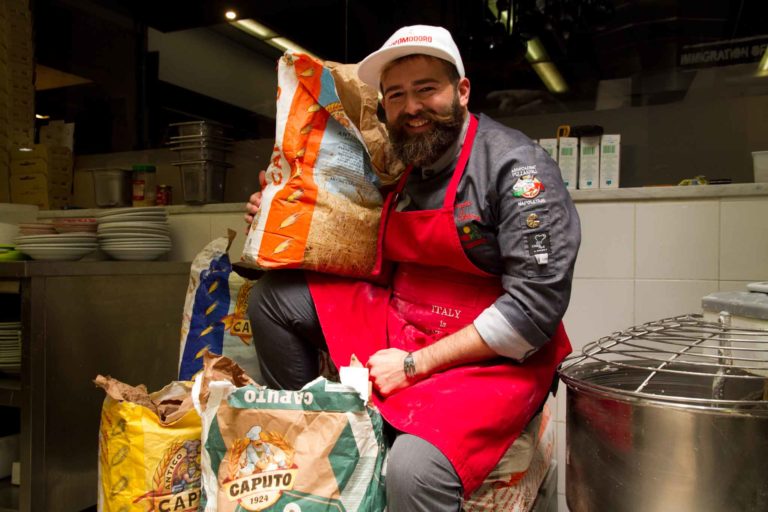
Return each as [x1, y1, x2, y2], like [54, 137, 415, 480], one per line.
[381, 56, 469, 167]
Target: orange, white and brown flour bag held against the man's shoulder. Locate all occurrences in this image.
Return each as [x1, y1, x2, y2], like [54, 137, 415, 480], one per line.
[242, 52, 402, 277]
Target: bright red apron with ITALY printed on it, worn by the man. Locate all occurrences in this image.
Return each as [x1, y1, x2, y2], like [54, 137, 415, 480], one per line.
[308, 116, 571, 496]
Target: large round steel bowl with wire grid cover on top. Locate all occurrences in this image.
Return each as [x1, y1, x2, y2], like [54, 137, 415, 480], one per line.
[561, 313, 768, 512]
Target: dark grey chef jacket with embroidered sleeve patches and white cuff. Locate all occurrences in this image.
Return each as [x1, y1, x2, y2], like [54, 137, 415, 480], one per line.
[397, 115, 581, 361]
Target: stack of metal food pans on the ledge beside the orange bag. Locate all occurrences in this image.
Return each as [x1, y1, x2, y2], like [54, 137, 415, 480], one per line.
[169, 121, 232, 204]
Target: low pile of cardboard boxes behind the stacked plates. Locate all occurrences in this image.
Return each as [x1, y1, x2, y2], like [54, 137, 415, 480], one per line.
[11, 144, 72, 210]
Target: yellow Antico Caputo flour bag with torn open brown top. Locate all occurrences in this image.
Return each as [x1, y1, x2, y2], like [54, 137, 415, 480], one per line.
[94, 375, 201, 512]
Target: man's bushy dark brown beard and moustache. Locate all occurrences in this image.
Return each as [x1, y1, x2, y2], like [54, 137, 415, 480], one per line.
[387, 97, 464, 167]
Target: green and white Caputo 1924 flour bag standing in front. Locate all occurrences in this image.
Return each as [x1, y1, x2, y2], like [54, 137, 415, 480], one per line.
[193, 355, 386, 512]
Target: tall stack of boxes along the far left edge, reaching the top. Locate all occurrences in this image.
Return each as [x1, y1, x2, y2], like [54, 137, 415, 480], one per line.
[0, 0, 35, 202]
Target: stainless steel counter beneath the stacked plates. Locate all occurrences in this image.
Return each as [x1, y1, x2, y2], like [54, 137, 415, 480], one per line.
[0, 261, 190, 512]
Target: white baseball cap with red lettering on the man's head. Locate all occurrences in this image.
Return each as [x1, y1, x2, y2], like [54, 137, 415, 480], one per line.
[357, 25, 464, 89]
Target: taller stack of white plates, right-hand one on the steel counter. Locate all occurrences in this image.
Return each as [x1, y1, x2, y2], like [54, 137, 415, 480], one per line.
[97, 206, 171, 260]
